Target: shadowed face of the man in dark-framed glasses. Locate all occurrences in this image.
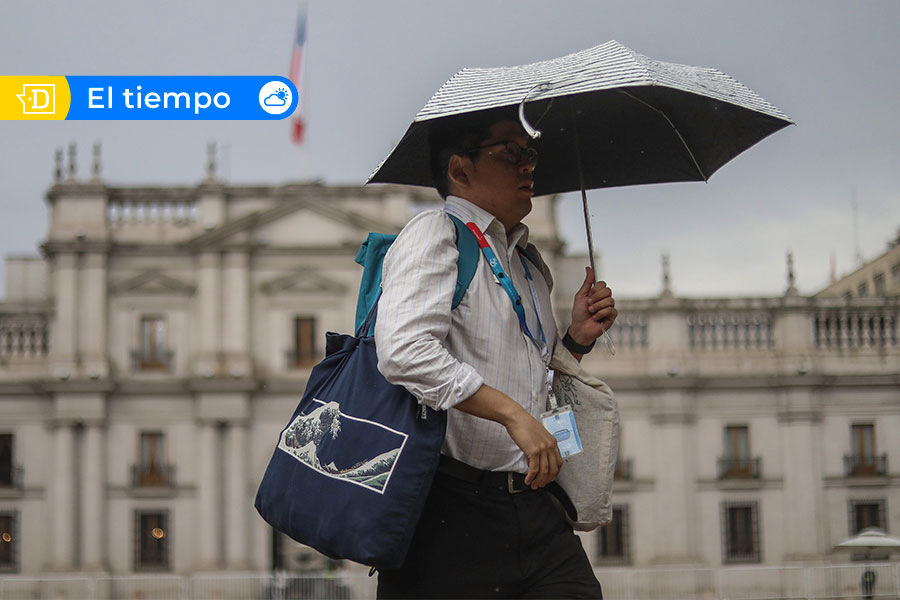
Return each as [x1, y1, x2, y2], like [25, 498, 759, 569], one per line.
[466, 121, 534, 230]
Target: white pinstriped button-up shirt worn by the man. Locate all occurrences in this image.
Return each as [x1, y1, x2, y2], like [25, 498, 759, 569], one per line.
[375, 196, 556, 473]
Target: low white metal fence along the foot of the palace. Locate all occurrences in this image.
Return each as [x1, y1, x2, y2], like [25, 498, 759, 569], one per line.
[0, 562, 900, 600]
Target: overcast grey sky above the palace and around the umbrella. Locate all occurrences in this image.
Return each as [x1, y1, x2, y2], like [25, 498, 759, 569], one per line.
[0, 0, 900, 296]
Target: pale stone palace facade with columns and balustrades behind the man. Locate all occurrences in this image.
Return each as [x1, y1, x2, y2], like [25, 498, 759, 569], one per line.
[0, 148, 900, 575]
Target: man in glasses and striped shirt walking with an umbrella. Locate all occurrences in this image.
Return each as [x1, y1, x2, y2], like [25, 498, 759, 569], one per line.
[375, 111, 617, 598]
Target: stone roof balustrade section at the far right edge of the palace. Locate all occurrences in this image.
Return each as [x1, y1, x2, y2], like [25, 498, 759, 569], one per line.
[813, 306, 900, 349]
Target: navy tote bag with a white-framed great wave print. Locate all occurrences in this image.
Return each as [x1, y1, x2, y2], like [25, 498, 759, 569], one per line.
[256, 318, 447, 569]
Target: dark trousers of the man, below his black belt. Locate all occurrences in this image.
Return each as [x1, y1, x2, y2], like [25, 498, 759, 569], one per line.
[378, 460, 602, 598]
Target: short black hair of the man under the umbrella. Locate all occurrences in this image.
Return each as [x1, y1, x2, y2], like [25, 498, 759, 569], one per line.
[428, 107, 518, 198]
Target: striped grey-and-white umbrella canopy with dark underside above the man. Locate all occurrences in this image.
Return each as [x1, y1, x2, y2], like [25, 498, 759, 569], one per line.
[368, 41, 792, 195]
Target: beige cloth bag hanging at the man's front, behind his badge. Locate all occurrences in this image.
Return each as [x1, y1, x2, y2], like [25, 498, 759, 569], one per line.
[548, 337, 619, 531]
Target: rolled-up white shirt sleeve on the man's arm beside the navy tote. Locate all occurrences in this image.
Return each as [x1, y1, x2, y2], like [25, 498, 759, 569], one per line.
[375, 210, 484, 410]
